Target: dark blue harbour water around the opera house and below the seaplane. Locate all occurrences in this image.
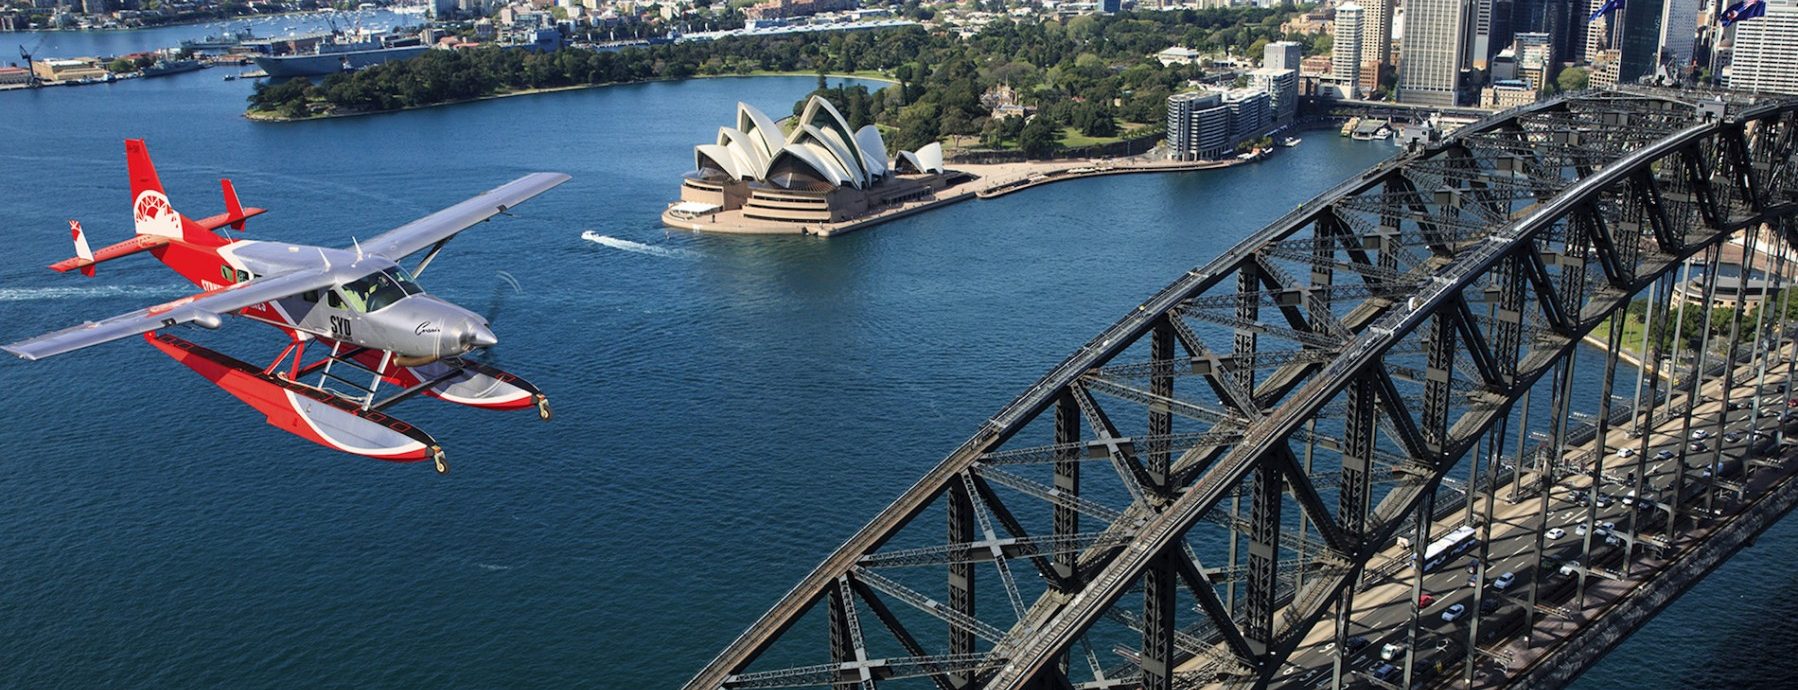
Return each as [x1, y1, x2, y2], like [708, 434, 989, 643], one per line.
[0, 64, 1798, 688]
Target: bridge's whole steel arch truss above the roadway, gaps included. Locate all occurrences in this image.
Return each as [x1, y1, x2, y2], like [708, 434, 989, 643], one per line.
[687, 90, 1798, 690]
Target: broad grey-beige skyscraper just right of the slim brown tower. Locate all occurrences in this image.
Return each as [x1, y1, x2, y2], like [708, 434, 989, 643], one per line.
[1399, 0, 1474, 108]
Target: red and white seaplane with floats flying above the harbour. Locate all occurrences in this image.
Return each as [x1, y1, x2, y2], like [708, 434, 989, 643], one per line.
[0, 140, 568, 473]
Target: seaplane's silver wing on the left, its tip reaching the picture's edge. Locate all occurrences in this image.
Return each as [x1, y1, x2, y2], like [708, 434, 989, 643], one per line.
[0, 268, 338, 359]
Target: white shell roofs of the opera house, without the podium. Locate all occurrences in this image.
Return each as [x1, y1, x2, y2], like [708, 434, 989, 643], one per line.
[694, 95, 942, 190]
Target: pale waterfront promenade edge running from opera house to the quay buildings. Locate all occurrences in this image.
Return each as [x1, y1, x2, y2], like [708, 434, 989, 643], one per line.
[662, 153, 1269, 237]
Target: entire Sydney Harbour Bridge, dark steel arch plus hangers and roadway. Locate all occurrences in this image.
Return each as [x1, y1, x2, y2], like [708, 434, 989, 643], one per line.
[687, 88, 1798, 690]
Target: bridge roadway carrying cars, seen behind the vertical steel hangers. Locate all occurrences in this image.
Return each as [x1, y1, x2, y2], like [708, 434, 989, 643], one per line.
[1258, 349, 1791, 688]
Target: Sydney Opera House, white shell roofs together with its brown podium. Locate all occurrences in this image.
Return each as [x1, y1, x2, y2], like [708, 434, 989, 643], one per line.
[662, 95, 955, 234]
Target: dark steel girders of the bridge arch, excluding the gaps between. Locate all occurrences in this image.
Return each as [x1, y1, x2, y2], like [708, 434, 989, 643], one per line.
[687, 88, 1798, 690]
